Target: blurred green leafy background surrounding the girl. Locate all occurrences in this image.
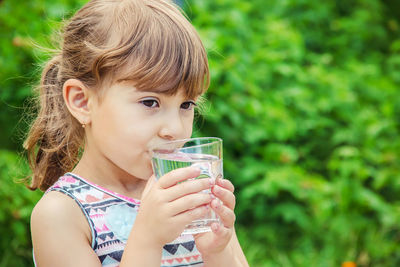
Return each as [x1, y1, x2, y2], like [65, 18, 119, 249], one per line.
[0, 0, 400, 267]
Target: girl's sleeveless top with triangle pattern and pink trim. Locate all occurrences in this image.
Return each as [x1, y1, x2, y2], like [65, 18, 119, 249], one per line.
[46, 173, 203, 267]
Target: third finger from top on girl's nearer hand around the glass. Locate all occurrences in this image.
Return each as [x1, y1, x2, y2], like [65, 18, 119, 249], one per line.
[169, 193, 213, 216]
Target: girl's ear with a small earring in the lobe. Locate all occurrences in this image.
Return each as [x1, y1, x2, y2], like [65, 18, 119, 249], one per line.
[63, 79, 94, 125]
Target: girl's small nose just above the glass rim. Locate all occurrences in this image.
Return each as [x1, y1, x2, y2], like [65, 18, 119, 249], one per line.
[159, 113, 185, 140]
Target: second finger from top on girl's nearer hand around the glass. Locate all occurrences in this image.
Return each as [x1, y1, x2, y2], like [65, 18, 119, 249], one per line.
[166, 178, 212, 201]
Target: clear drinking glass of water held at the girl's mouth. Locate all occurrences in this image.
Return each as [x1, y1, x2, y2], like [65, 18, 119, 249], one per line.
[152, 137, 223, 234]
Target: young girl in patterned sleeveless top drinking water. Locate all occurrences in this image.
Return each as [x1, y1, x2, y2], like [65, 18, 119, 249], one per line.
[25, 0, 248, 267]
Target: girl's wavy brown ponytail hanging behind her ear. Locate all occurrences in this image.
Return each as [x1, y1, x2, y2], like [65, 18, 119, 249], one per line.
[24, 55, 84, 191]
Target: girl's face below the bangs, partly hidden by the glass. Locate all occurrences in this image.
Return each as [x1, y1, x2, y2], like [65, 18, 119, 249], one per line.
[87, 82, 195, 179]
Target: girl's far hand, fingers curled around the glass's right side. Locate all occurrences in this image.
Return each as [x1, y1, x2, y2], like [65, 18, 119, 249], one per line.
[195, 179, 236, 259]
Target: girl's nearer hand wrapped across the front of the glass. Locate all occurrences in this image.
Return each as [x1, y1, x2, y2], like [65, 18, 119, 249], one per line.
[131, 167, 212, 247]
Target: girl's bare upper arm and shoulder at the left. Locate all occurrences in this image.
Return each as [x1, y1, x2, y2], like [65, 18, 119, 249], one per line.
[31, 192, 101, 267]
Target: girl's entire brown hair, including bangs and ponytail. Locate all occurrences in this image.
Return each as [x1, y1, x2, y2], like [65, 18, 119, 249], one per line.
[24, 0, 209, 191]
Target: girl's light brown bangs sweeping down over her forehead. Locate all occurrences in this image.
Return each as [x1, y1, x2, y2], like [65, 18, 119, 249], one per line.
[108, 0, 210, 98]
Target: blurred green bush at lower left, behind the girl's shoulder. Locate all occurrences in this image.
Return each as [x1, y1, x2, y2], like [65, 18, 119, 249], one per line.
[0, 150, 40, 267]
